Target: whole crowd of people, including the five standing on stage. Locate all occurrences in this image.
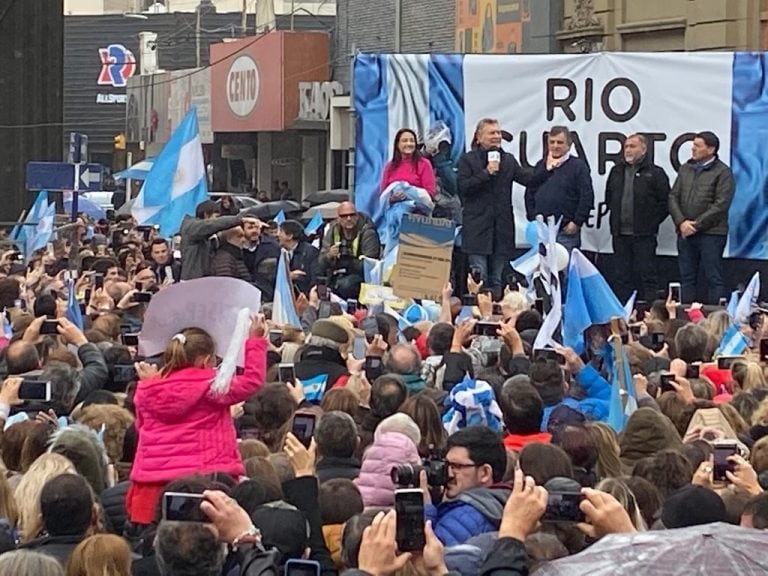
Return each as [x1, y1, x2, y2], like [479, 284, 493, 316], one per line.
[0, 115, 752, 576]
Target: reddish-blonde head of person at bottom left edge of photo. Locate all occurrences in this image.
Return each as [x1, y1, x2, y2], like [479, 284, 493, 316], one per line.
[67, 534, 131, 576]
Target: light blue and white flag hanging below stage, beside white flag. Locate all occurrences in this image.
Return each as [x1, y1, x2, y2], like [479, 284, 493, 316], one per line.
[563, 249, 624, 354]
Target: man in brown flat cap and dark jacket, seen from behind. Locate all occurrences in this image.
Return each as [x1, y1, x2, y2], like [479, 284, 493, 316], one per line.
[295, 320, 349, 400]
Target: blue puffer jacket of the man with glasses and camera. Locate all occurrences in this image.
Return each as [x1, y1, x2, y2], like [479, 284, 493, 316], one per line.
[425, 485, 511, 546]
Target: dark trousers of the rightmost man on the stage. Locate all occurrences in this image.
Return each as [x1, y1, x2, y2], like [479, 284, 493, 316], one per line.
[677, 233, 726, 304]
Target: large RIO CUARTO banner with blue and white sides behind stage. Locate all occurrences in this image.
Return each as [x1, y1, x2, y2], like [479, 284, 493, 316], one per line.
[354, 52, 768, 259]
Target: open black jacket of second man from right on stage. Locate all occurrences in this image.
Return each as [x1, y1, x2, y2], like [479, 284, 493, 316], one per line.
[605, 156, 669, 236]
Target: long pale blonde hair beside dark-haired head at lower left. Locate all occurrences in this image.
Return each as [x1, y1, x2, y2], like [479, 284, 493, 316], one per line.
[13, 453, 77, 543]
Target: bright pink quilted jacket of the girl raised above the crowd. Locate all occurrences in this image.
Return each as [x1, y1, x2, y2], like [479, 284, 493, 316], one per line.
[131, 338, 267, 482]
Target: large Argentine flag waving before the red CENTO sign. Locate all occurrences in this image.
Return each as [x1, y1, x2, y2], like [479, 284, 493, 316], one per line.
[131, 108, 208, 238]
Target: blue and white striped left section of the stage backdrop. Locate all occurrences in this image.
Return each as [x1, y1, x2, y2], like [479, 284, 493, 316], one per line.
[354, 54, 466, 230]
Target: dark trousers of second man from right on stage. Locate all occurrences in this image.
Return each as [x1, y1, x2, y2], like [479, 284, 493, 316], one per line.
[613, 236, 658, 303]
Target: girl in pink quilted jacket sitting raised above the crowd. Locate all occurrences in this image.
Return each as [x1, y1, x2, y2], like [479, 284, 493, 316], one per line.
[126, 315, 267, 524]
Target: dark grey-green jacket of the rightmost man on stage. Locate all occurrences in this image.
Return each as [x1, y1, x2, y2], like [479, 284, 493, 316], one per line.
[669, 157, 735, 236]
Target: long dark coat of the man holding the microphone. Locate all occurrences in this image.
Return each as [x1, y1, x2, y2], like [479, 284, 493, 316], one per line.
[458, 148, 544, 257]
